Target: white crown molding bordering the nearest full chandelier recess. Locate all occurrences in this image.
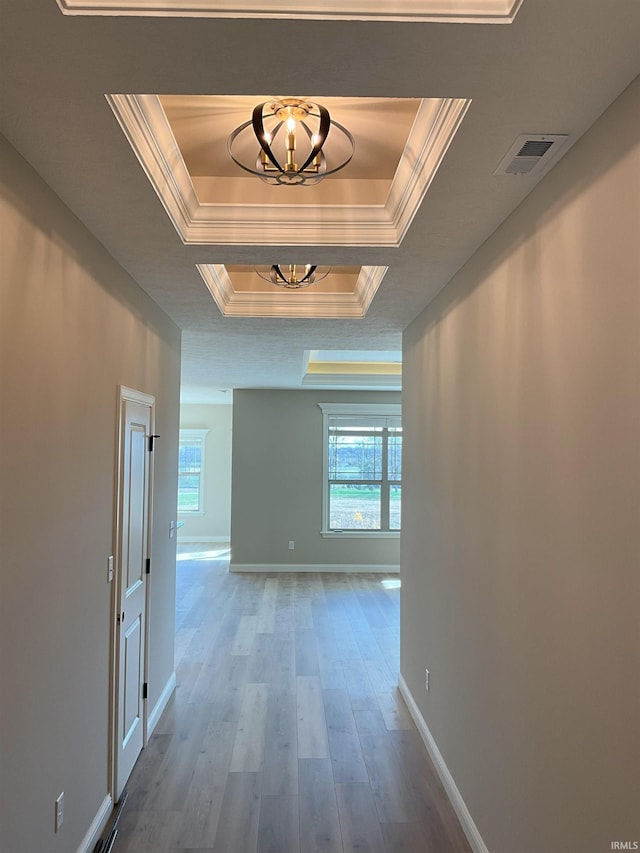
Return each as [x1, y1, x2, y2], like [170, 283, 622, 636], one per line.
[105, 95, 471, 248]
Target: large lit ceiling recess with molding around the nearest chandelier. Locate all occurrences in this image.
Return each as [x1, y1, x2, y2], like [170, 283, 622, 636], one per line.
[107, 95, 470, 246]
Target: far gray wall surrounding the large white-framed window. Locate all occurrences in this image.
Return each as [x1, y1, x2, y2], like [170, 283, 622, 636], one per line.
[231, 391, 400, 568]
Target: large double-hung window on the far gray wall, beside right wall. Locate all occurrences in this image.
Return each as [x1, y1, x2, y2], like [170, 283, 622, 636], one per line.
[318, 403, 402, 536]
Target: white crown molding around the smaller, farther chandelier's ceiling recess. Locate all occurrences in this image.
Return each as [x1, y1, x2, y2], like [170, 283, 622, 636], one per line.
[196, 264, 388, 319]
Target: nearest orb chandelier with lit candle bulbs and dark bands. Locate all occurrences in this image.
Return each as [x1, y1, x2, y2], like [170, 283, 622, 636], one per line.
[227, 98, 355, 186]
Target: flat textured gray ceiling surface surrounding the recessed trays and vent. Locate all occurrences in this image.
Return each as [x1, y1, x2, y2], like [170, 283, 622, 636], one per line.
[0, 0, 640, 400]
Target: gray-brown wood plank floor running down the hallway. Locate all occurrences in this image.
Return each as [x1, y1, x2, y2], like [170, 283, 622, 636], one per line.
[114, 548, 470, 853]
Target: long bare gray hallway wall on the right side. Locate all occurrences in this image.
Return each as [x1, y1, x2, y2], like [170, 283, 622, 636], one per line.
[402, 80, 640, 853]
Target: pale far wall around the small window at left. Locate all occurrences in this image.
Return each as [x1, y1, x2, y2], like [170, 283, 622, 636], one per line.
[178, 404, 233, 542]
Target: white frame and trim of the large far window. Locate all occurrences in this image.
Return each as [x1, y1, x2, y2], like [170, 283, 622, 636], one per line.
[318, 403, 402, 539]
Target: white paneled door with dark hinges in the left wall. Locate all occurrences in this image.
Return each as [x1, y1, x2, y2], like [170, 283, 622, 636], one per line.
[115, 389, 153, 800]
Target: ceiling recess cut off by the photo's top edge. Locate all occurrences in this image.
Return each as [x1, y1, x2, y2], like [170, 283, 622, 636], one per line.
[57, 0, 523, 24]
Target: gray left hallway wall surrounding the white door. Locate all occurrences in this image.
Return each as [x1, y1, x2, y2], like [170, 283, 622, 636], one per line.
[0, 137, 180, 853]
